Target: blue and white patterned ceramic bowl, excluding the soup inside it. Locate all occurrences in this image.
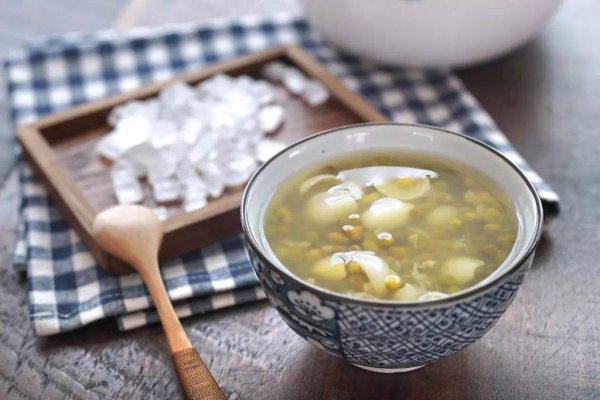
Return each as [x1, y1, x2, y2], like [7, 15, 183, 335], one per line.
[242, 123, 543, 372]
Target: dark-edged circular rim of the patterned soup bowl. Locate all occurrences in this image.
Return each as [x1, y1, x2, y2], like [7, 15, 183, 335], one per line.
[240, 121, 544, 309]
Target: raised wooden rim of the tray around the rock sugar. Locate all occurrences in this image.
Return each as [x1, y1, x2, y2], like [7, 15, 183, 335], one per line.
[17, 45, 386, 274]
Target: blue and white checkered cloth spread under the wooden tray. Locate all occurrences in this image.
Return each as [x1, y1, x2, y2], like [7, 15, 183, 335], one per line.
[5, 15, 558, 335]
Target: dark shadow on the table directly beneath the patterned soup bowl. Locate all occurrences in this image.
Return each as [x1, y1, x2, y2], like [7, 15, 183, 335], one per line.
[279, 345, 506, 400]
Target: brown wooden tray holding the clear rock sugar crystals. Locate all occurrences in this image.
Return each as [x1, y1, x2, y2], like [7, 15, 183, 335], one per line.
[18, 46, 385, 274]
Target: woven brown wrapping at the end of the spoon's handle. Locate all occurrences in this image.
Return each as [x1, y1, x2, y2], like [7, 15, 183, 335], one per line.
[171, 348, 226, 400]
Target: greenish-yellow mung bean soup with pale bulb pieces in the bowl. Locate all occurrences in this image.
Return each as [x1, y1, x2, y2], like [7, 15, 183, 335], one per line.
[264, 153, 517, 301]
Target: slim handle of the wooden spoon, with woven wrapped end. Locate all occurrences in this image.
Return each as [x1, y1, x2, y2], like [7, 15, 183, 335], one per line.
[138, 262, 225, 400]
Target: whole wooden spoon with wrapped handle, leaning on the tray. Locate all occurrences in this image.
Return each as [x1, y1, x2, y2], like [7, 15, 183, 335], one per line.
[93, 205, 225, 400]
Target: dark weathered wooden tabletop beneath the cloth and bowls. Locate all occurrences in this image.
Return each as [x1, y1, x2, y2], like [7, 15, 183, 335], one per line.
[0, 0, 600, 400]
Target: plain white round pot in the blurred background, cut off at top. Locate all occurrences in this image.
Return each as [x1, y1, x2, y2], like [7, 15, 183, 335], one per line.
[302, 0, 561, 67]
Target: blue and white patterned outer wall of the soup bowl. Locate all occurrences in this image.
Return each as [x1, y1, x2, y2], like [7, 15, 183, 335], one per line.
[248, 246, 533, 372]
